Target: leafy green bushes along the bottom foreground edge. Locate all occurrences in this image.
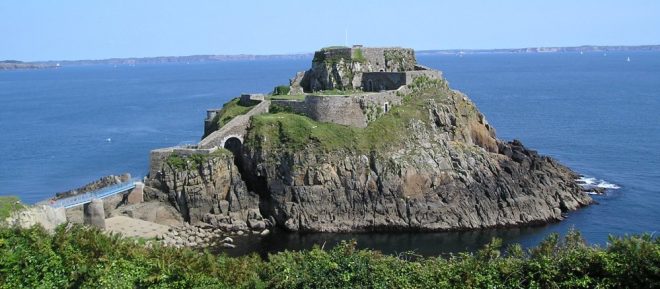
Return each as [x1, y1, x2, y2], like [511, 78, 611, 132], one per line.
[0, 226, 660, 288]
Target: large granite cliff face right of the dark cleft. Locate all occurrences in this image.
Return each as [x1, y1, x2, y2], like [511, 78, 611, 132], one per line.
[243, 77, 591, 232]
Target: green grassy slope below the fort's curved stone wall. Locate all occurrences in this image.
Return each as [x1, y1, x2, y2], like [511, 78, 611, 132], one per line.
[245, 77, 449, 153]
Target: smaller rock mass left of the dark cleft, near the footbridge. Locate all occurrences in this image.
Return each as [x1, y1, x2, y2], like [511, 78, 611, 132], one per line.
[148, 149, 264, 230]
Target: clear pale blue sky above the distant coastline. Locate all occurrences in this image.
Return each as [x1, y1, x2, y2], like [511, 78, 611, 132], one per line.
[0, 0, 660, 61]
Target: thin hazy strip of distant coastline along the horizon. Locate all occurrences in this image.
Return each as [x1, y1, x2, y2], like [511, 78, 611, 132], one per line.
[0, 45, 660, 70]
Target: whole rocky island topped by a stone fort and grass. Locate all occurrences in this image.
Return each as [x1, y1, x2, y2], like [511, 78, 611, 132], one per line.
[145, 46, 591, 232]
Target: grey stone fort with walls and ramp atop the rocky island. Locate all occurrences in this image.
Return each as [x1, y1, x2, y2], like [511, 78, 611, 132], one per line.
[149, 45, 442, 170]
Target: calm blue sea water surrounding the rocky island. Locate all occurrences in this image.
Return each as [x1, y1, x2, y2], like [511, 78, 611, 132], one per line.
[0, 52, 660, 255]
